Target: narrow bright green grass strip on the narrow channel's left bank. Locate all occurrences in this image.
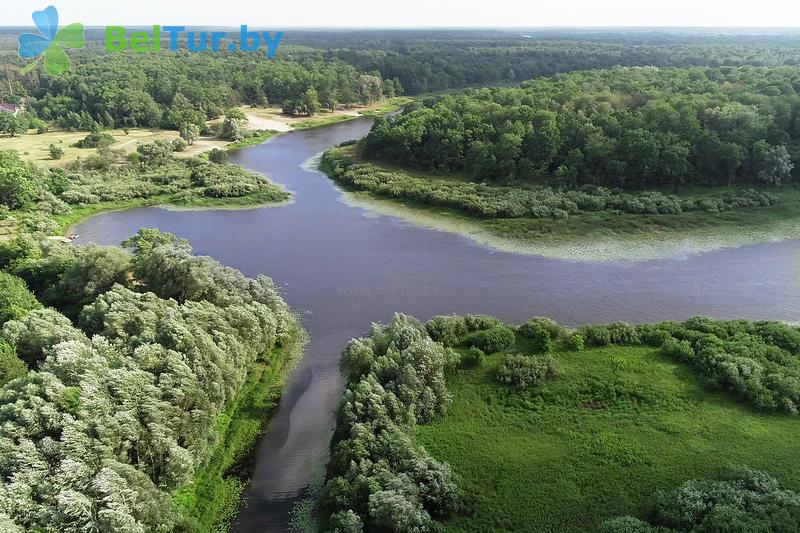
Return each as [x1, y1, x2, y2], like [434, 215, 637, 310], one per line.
[174, 321, 308, 531]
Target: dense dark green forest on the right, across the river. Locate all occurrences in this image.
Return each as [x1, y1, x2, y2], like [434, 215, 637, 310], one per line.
[362, 67, 800, 188]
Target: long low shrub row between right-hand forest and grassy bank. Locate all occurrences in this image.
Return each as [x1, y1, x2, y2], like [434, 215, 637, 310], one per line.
[320, 148, 777, 218]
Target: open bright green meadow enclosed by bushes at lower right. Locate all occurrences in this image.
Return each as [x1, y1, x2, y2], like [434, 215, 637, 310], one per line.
[416, 346, 800, 532]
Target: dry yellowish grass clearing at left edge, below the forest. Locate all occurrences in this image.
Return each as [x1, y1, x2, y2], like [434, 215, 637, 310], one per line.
[0, 128, 229, 167]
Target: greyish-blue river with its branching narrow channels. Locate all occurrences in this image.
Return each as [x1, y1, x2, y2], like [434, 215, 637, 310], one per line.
[75, 119, 800, 532]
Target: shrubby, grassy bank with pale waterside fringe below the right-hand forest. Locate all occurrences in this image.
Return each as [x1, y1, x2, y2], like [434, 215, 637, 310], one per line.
[320, 146, 800, 261]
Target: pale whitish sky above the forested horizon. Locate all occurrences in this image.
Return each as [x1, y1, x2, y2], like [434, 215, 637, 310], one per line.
[0, 0, 800, 29]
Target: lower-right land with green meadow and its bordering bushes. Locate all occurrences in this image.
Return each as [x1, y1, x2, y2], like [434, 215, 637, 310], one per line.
[321, 315, 800, 533]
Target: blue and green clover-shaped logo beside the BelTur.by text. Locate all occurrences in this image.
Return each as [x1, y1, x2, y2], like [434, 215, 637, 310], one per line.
[19, 6, 85, 76]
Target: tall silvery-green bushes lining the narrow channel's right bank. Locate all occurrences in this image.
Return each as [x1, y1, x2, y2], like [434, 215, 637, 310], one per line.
[322, 314, 461, 533]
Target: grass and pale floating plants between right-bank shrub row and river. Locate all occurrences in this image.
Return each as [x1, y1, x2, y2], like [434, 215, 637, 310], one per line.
[323, 148, 800, 261]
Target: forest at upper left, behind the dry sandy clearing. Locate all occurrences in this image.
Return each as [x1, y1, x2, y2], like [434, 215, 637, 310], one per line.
[0, 49, 402, 131]
